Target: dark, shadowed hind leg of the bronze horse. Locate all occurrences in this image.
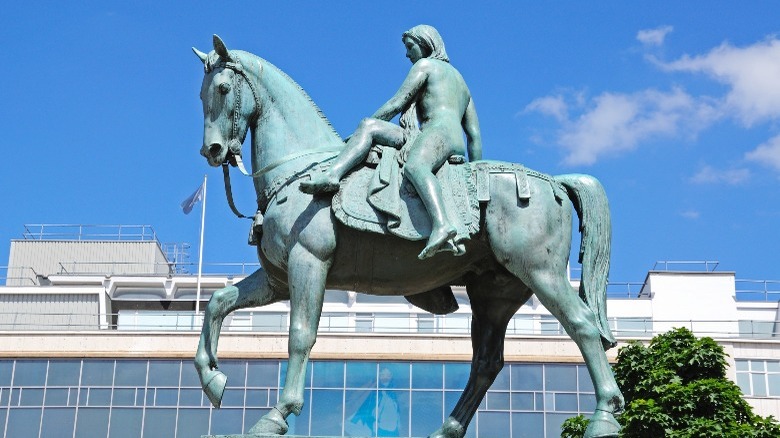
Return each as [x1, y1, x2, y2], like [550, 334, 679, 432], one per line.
[430, 271, 531, 438]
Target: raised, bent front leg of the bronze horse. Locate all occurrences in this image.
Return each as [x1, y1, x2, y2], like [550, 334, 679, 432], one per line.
[195, 269, 284, 407]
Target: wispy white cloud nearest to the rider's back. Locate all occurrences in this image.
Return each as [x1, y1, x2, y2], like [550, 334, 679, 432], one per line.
[526, 89, 718, 165]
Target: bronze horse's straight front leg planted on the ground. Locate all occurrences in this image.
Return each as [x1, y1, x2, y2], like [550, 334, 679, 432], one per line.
[249, 245, 331, 435]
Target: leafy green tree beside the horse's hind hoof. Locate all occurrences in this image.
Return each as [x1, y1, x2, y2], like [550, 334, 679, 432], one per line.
[561, 328, 780, 438]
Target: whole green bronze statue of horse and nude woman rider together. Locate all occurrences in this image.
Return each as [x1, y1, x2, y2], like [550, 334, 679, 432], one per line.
[193, 25, 624, 438]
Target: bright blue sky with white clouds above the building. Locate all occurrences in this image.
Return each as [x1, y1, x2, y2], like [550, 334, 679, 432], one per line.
[0, 1, 780, 281]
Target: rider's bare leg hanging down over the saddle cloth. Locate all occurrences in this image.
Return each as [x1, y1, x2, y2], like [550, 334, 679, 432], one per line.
[404, 139, 457, 259]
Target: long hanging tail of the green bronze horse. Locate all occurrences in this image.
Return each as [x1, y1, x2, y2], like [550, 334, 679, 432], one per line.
[555, 174, 617, 350]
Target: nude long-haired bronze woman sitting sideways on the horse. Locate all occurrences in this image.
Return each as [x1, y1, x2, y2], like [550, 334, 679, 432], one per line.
[301, 24, 482, 259]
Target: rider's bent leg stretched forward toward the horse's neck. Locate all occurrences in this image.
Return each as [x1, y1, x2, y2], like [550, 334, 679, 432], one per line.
[300, 118, 404, 193]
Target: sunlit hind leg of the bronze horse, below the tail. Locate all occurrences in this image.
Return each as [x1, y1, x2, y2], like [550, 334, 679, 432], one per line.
[527, 270, 624, 438]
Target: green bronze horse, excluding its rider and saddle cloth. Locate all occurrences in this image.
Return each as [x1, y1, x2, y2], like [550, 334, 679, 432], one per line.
[193, 35, 624, 438]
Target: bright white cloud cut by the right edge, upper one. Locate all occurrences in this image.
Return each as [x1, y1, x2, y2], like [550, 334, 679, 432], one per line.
[656, 38, 780, 126]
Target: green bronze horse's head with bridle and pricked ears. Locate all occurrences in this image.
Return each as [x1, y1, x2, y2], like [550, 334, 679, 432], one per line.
[192, 35, 262, 166]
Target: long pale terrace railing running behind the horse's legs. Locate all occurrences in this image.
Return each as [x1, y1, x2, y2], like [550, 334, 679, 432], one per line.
[0, 311, 780, 341]
